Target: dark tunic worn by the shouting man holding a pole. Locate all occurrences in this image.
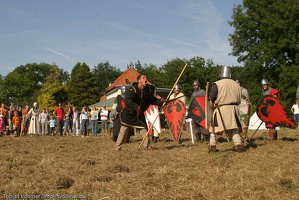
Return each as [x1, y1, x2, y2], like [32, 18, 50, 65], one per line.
[121, 83, 163, 129]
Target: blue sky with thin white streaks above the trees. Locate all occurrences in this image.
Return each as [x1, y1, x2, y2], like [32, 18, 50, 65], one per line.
[0, 0, 242, 76]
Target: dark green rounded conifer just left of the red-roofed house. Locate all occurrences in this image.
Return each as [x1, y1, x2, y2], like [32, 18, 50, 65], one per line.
[66, 62, 99, 108]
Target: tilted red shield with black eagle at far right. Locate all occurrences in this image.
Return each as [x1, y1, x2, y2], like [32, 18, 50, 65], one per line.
[256, 95, 296, 128]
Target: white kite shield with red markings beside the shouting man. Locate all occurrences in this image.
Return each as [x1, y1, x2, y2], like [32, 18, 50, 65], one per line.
[144, 105, 161, 135]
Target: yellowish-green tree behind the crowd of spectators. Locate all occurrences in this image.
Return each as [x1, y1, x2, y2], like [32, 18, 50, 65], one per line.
[38, 65, 67, 111]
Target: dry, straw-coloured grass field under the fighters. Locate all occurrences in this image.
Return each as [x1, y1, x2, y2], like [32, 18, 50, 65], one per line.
[0, 129, 299, 200]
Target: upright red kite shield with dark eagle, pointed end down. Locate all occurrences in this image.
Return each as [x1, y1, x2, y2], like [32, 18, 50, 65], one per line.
[164, 99, 186, 141]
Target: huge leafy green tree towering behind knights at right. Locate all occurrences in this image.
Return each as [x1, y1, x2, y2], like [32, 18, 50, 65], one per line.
[229, 0, 299, 106]
